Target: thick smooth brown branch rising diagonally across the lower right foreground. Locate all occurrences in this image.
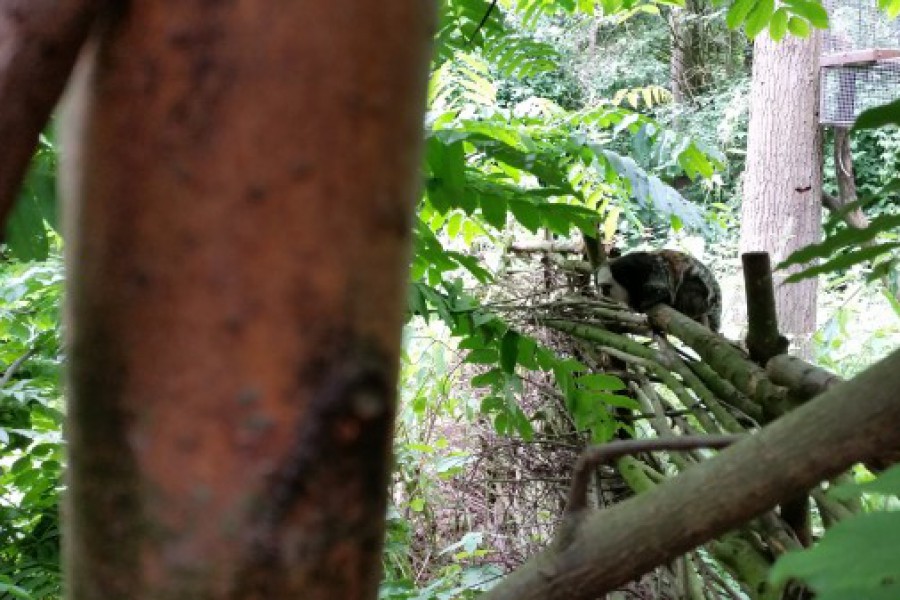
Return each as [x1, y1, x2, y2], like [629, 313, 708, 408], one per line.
[486, 351, 900, 600]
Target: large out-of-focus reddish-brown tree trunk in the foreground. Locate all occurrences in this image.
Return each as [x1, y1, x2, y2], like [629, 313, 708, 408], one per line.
[62, 0, 432, 600]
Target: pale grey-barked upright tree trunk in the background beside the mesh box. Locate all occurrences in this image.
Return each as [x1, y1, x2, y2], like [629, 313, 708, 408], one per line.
[740, 33, 822, 353]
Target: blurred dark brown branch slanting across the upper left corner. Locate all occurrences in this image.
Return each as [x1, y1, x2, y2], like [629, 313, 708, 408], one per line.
[0, 0, 105, 225]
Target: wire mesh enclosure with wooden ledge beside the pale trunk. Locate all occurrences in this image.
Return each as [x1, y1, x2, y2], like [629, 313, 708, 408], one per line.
[819, 0, 900, 127]
